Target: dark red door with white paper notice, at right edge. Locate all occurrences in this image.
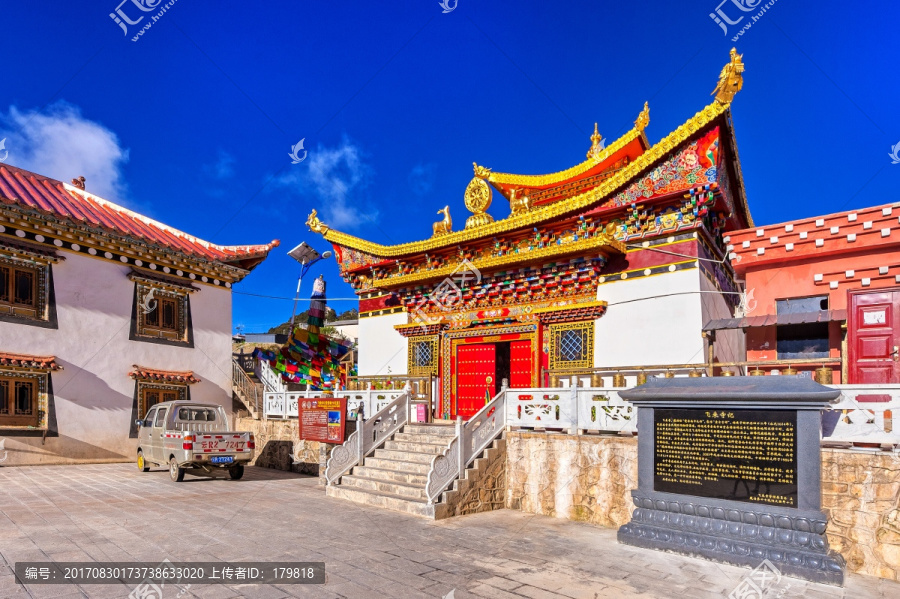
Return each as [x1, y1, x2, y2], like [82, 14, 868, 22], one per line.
[848, 291, 900, 384]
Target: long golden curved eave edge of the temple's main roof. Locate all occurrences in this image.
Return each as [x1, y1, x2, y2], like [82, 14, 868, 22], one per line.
[321, 101, 749, 258]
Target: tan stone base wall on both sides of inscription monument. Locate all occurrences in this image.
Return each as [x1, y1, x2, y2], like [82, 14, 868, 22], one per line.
[506, 431, 900, 580]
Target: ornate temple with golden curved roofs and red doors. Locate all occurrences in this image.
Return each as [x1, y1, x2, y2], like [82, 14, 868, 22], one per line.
[307, 50, 753, 418]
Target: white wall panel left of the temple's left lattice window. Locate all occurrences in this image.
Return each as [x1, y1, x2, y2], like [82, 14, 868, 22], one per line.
[358, 312, 409, 376]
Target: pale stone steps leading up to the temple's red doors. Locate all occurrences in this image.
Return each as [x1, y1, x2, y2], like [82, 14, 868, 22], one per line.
[326, 424, 506, 519]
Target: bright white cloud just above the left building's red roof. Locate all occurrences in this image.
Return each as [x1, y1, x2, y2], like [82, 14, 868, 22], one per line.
[0, 101, 128, 202]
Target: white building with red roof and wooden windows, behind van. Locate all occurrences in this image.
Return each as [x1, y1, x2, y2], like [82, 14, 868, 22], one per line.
[0, 165, 278, 466]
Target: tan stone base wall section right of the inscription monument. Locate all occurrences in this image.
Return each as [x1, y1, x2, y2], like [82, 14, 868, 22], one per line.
[822, 448, 900, 580]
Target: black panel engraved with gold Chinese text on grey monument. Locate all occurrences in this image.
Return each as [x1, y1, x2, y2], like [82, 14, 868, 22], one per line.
[653, 408, 797, 507]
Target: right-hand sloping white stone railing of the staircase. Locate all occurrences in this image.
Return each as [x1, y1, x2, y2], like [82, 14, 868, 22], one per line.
[425, 380, 508, 505]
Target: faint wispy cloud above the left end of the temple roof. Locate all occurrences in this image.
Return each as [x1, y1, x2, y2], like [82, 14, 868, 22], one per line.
[278, 136, 378, 229]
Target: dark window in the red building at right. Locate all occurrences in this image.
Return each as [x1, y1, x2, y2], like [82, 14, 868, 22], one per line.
[775, 295, 829, 360]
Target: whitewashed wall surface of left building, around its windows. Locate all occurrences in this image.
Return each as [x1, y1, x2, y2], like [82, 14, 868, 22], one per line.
[0, 250, 231, 466]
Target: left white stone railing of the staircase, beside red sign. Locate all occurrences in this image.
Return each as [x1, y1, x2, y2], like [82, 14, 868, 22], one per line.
[325, 387, 412, 485]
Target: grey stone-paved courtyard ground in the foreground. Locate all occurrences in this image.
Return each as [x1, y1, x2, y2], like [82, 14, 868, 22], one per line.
[0, 464, 900, 599]
